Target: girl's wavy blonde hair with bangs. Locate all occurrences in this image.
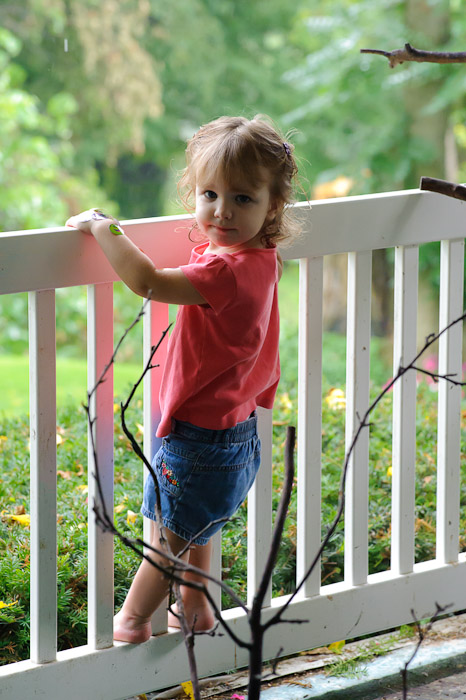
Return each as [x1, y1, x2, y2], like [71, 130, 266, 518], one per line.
[178, 115, 300, 247]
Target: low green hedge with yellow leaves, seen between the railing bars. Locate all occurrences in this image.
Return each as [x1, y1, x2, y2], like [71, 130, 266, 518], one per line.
[0, 374, 466, 673]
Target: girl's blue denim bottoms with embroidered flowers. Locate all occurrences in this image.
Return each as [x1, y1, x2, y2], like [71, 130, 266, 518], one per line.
[141, 414, 260, 545]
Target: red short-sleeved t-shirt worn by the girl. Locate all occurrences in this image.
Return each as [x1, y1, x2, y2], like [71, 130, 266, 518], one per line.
[157, 243, 280, 437]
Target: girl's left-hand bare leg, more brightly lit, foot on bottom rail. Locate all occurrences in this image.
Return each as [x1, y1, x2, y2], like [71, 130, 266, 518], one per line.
[113, 522, 189, 644]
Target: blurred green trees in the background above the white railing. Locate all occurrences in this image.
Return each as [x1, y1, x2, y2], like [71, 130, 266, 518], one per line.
[0, 0, 466, 334]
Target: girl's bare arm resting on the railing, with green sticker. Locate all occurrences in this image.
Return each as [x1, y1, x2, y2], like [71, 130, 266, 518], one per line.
[66, 210, 206, 304]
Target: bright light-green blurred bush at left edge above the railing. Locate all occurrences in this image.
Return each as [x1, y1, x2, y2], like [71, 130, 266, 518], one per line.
[0, 28, 116, 231]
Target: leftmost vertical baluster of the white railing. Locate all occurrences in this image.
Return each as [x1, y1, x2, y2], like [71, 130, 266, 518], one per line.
[29, 290, 57, 664]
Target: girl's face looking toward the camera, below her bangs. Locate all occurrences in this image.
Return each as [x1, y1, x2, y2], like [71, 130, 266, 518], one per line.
[196, 170, 276, 253]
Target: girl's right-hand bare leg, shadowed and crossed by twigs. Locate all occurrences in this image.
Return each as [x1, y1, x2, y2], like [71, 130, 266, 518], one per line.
[168, 540, 215, 632]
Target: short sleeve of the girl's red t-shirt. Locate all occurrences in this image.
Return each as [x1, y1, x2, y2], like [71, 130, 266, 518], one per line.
[180, 255, 236, 314]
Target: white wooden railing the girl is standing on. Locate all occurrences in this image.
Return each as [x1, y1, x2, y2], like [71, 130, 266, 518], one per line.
[0, 190, 466, 700]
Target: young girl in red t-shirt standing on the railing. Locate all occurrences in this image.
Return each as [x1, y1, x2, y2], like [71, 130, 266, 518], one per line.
[67, 117, 297, 643]
